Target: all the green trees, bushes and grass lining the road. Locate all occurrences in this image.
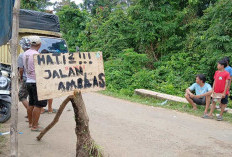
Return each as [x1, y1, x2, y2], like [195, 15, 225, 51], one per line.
[21, 0, 232, 119]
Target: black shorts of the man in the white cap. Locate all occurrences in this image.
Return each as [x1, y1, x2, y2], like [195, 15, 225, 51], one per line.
[26, 83, 47, 108]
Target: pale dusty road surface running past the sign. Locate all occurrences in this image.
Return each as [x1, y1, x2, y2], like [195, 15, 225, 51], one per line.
[2, 93, 232, 157]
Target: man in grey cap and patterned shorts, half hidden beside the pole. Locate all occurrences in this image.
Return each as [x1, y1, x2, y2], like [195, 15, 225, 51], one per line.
[18, 38, 31, 112]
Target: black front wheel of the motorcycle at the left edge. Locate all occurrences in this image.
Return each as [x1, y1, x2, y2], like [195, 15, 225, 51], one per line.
[0, 101, 11, 123]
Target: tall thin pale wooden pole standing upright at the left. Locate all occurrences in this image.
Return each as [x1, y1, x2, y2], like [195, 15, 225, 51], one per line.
[10, 0, 20, 157]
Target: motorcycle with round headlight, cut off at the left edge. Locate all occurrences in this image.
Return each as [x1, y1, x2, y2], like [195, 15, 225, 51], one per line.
[0, 68, 11, 123]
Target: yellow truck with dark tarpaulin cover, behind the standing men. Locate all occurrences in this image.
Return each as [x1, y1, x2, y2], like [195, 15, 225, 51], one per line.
[0, 9, 68, 67]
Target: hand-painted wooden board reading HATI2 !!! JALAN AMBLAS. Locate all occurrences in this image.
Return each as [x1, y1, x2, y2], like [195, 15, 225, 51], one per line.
[34, 52, 106, 100]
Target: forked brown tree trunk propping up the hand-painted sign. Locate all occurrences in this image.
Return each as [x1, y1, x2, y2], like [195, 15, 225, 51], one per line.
[37, 91, 103, 157]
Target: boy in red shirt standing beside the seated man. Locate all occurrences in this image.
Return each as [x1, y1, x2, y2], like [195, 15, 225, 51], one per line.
[203, 60, 230, 121]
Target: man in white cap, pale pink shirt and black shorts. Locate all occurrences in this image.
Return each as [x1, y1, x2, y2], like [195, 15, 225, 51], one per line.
[23, 36, 47, 131]
